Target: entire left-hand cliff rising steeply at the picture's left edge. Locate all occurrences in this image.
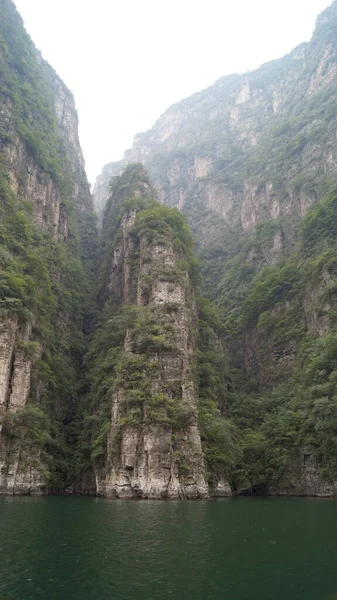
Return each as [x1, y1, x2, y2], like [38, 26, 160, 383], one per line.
[0, 0, 96, 494]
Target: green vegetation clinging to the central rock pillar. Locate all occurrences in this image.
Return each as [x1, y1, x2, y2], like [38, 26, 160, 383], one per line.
[80, 165, 236, 488]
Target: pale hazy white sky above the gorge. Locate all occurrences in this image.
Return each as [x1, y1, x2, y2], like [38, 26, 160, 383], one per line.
[14, 0, 331, 182]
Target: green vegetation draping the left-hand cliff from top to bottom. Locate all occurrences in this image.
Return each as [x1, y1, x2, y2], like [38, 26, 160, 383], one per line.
[0, 0, 96, 490]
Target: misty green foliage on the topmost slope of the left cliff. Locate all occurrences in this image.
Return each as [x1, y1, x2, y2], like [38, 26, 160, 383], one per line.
[0, 0, 66, 184]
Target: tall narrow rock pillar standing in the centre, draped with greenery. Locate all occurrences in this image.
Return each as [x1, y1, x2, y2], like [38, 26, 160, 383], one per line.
[82, 165, 231, 498]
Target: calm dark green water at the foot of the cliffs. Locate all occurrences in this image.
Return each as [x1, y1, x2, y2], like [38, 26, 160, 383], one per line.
[0, 498, 337, 600]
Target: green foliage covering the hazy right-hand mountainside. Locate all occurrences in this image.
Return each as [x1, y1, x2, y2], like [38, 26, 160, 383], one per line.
[89, 3, 337, 492]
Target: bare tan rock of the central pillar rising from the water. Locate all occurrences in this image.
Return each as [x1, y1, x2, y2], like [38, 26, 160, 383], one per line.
[97, 213, 208, 498]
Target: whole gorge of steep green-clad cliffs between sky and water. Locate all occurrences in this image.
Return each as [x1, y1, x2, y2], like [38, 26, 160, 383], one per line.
[0, 0, 337, 499]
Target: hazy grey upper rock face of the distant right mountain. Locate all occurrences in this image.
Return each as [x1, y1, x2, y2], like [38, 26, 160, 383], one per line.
[94, 2, 337, 252]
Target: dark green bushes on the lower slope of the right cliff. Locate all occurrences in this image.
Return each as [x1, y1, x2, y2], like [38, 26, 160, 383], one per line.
[222, 188, 337, 491]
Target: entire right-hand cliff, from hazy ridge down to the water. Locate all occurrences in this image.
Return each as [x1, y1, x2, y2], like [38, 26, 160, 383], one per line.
[94, 2, 337, 495]
